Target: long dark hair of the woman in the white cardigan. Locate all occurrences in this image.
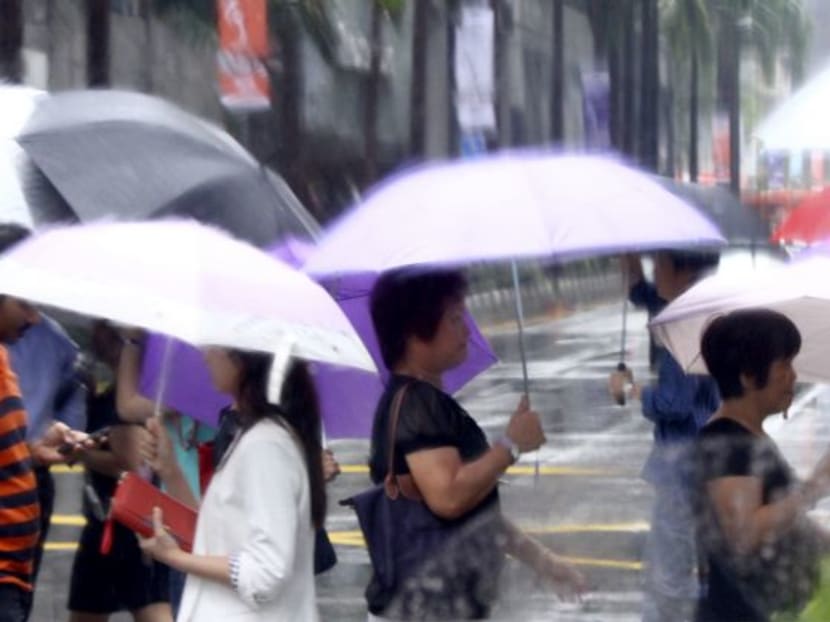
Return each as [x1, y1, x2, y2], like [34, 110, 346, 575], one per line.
[231, 350, 326, 528]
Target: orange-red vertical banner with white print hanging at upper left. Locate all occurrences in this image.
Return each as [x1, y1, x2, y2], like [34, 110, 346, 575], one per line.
[216, 0, 271, 110]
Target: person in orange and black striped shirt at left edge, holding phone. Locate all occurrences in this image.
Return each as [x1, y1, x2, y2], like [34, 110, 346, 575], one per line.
[0, 270, 86, 622]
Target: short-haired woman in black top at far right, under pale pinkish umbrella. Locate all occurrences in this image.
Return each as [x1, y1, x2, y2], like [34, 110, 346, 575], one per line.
[696, 309, 830, 622]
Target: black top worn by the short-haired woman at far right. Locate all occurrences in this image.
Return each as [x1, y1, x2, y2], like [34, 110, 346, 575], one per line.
[697, 419, 796, 622]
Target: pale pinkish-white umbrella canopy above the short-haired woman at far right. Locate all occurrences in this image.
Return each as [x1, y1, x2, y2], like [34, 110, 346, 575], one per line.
[651, 254, 830, 382]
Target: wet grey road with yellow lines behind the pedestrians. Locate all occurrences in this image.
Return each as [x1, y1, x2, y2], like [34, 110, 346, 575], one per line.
[33, 304, 830, 622]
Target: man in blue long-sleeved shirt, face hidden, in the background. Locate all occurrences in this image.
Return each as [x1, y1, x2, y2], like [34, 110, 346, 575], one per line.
[609, 251, 720, 622]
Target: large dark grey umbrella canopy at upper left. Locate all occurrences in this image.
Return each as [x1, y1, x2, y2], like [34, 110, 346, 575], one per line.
[17, 90, 318, 245]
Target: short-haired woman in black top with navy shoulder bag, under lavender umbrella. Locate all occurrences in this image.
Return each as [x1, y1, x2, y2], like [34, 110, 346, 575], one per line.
[366, 270, 585, 620]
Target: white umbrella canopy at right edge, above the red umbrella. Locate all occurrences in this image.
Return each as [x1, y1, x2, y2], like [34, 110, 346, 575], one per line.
[755, 66, 830, 152]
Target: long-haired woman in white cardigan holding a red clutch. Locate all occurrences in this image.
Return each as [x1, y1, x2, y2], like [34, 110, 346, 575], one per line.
[142, 348, 326, 622]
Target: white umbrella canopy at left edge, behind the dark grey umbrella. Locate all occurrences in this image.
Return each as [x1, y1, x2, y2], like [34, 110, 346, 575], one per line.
[0, 85, 75, 228]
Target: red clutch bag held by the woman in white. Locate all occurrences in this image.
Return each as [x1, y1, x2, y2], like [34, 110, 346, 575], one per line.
[101, 473, 197, 552]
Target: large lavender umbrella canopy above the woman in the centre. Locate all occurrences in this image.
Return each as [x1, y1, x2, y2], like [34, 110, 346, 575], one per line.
[304, 152, 724, 274]
